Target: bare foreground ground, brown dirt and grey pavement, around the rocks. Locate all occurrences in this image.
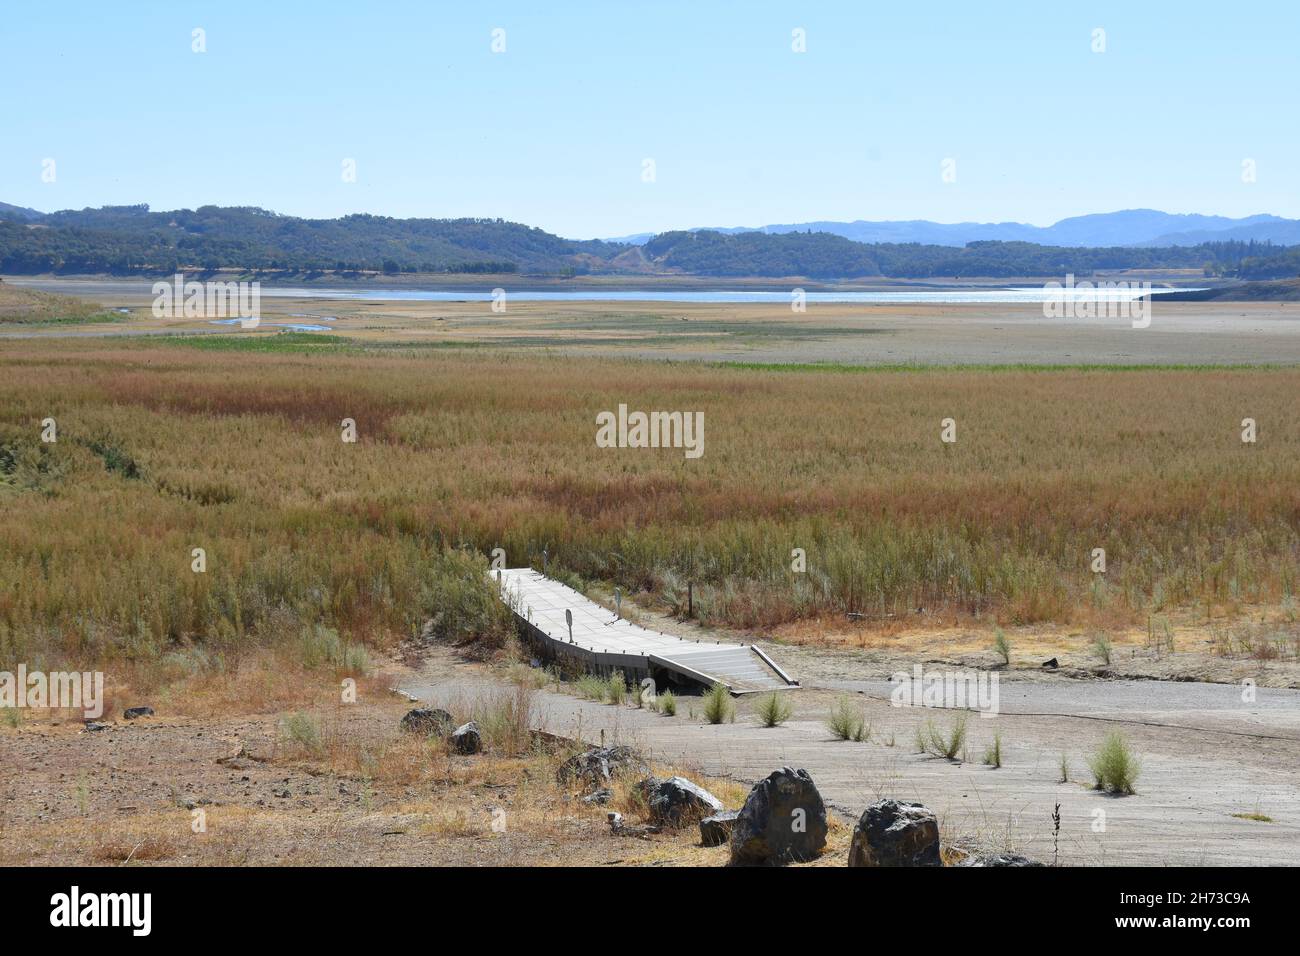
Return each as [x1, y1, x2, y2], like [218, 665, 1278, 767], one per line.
[0, 629, 1300, 866]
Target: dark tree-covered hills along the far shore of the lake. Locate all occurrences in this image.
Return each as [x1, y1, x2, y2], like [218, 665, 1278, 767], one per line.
[0, 206, 1300, 280]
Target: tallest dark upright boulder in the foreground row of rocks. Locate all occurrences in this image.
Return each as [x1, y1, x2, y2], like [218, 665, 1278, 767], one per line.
[731, 767, 827, 866]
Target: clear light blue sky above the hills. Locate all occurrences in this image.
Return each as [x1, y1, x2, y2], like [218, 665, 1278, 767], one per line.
[0, 0, 1300, 238]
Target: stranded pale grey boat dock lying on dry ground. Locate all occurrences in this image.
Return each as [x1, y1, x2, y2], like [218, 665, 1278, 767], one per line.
[493, 567, 798, 695]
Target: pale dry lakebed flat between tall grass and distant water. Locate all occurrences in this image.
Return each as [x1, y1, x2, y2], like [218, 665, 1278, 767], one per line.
[0, 278, 1300, 365]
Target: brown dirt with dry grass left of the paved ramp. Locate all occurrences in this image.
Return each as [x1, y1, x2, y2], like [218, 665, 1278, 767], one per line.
[0, 649, 850, 866]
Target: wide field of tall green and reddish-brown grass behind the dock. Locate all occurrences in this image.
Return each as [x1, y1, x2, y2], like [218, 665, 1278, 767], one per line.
[0, 336, 1300, 687]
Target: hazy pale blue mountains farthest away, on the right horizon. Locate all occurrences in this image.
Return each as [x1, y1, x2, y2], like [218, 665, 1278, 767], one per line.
[623, 209, 1300, 247]
